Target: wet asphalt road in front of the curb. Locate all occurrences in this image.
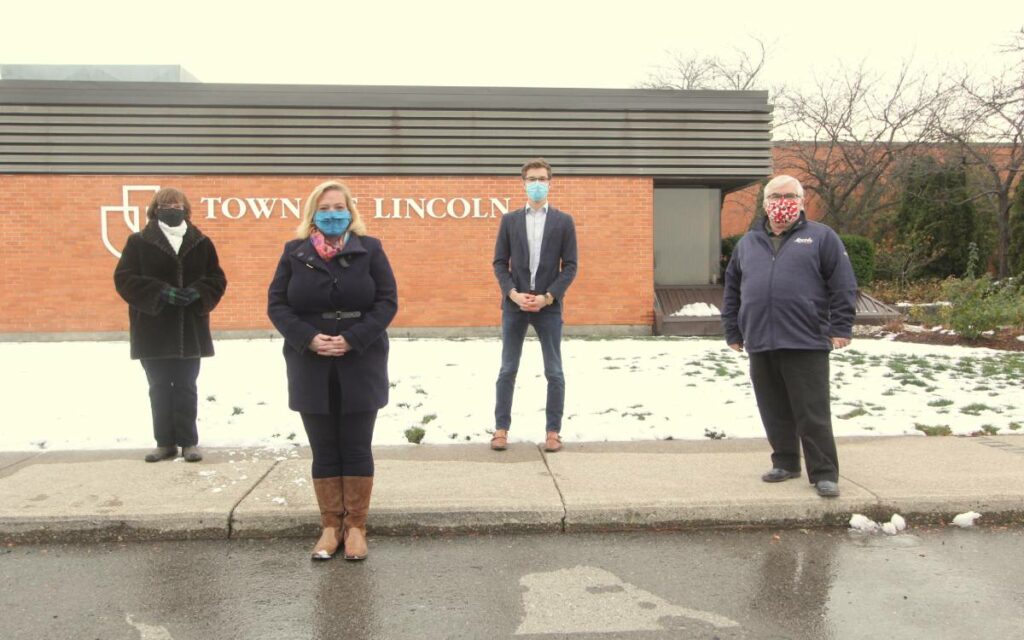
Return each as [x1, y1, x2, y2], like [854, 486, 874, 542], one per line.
[0, 528, 1024, 640]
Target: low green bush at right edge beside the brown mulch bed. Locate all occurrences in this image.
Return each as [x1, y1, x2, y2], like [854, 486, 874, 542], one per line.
[942, 273, 1024, 338]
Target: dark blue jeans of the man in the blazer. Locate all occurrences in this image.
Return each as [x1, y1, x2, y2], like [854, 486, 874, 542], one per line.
[495, 303, 565, 432]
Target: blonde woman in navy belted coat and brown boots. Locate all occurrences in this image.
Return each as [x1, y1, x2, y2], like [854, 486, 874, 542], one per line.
[267, 181, 398, 560]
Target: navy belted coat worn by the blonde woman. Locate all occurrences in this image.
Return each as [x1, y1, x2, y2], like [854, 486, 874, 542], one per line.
[267, 233, 398, 414]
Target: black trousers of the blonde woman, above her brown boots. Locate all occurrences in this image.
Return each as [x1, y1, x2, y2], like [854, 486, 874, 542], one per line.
[301, 366, 377, 478]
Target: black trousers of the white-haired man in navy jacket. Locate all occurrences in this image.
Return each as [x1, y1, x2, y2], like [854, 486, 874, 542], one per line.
[750, 349, 839, 482]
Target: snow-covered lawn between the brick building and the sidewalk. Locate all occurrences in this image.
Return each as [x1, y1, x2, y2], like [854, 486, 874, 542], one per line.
[0, 338, 1024, 451]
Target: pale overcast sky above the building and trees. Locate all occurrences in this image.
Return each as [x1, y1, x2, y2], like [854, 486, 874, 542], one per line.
[0, 0, 1024, 88]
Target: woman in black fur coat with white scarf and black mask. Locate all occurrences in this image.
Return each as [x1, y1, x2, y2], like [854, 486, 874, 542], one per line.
[114, 188, 227, 462]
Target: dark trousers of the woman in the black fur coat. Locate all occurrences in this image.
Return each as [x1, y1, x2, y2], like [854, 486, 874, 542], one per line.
[139, 357, 200, 446]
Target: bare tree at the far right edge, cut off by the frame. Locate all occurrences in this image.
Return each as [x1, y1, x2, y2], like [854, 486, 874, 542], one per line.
[935, 29, 1024, 278]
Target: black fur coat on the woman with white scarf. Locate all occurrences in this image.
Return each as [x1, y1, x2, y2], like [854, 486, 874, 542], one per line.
[114, 219, 227, 359]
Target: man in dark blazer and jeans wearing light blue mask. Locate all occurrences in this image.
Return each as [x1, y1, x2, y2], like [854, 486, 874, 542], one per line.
[490, 158, 577, 452]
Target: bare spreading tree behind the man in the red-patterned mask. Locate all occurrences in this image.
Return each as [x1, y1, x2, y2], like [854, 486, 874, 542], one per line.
[775, 62, 936, 234]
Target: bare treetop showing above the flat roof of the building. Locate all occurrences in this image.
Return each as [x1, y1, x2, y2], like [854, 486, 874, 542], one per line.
[637, 38, 768, 90]
